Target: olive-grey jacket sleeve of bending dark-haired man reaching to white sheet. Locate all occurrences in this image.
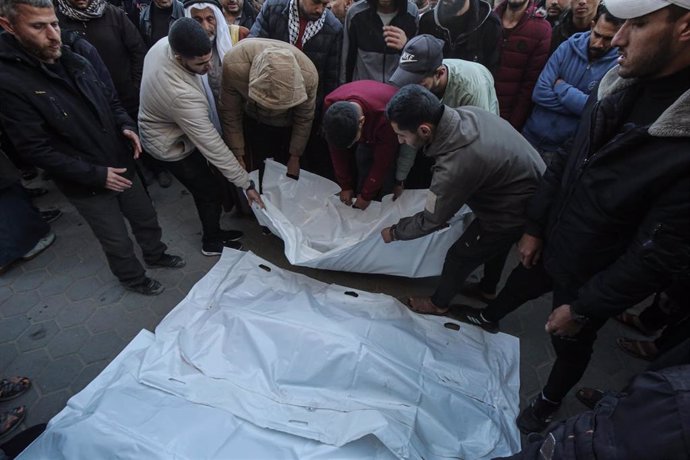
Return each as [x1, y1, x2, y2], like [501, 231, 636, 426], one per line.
[393, 150, 482, 240]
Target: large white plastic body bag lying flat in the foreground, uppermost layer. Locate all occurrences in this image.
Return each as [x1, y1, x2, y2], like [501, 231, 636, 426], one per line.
[139, 252, 519, 459]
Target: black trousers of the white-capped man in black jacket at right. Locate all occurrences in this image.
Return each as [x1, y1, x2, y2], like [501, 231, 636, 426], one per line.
[483, 263, 606, 402]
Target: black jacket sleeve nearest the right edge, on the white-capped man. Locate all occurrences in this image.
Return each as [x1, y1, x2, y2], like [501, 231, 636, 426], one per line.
[571, 176, 690, 318]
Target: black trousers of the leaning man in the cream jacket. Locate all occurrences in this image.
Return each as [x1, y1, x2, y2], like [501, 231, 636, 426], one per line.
[167, 150, 223, 242]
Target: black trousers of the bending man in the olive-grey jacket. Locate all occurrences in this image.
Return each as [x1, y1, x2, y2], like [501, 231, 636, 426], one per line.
[431, 219, 522, 308]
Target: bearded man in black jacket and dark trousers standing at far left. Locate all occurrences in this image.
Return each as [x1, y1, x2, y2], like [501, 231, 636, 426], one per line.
[0, 0, 184, 295]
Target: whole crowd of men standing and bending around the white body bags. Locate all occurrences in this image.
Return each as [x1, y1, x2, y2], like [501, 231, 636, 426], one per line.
[0, 0, 690, 452]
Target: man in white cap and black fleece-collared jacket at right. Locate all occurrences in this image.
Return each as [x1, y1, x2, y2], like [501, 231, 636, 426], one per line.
[452, 0, 690, 432]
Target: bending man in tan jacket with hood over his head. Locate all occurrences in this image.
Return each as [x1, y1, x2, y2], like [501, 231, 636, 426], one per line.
[220, 38, 319, 179]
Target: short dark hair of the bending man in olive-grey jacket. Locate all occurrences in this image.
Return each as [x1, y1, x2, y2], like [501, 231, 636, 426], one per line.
[386, 85, 443, 132]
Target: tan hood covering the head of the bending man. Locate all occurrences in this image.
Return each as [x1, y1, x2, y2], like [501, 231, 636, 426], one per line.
[248, 48, 307, 110]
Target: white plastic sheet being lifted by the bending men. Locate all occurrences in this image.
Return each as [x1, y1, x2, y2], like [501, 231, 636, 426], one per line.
[252, 160, 472, 278]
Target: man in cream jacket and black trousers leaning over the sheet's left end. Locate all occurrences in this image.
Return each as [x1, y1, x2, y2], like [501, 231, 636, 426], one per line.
[139, 18, 263, 256]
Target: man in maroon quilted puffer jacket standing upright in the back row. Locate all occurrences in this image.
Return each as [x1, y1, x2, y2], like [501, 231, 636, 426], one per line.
[494, 0, 551, 131]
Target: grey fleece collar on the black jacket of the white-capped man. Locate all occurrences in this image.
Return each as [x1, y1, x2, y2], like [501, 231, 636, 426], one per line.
[597, 66, 690, 137]
